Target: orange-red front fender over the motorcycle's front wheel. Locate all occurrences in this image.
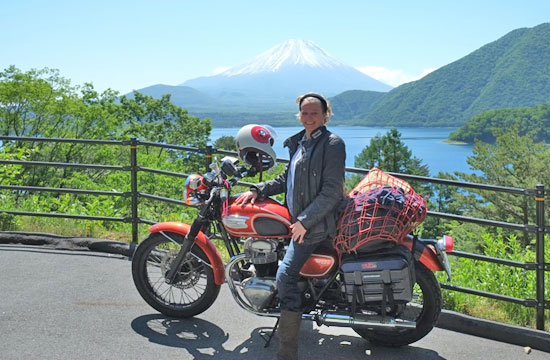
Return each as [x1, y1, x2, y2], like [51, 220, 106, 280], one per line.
[149, 222, 225, 285]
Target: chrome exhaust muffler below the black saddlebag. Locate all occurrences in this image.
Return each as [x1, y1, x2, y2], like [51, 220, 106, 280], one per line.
[312, 311, 416, 329]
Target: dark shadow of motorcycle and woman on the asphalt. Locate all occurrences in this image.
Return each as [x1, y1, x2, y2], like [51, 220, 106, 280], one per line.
[131, 314, 444, 360]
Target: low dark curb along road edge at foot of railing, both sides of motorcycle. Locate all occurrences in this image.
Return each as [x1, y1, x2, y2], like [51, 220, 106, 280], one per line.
[0, 231, 550, 352]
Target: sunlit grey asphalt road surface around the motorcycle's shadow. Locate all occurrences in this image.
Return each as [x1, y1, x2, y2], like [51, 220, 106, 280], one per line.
[0, 245, 550, 360]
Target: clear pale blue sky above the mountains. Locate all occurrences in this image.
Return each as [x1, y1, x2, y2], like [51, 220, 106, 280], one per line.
[0, 0, 550, 93]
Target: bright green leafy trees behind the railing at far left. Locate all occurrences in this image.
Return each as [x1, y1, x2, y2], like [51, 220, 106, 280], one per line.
[0, 66, 211, 236]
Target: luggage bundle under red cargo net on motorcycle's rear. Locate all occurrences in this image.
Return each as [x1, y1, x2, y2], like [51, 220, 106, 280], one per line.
[333, 168, 426, 255]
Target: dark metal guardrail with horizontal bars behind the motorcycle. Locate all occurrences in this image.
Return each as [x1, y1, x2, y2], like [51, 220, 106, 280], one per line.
[0, 136, 550, 330]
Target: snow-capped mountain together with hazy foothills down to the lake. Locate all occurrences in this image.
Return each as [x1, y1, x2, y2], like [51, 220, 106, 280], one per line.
[132, 40, 392, 126]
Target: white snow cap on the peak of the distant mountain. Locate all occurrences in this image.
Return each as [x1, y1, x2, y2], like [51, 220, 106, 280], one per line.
[220, 39, 345, 76]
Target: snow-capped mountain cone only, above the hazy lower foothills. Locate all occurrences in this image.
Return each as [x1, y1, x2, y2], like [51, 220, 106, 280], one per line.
[181, 40, 391, 105]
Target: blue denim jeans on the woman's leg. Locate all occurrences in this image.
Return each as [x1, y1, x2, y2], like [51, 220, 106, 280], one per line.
[277, 240, 323, 313]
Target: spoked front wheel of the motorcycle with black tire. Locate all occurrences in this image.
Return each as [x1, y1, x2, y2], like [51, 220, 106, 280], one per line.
[132, 233, 220, 317]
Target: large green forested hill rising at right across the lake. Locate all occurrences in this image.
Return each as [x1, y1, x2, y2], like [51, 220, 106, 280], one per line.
[350, 23, 550, 126]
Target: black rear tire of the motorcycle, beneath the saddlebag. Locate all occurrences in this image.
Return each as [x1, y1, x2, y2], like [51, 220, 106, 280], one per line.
[353, 263, 441, 347]
